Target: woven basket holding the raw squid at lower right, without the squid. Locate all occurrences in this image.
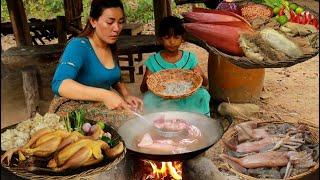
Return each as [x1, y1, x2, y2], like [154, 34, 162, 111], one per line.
[222, 121, 319, 180]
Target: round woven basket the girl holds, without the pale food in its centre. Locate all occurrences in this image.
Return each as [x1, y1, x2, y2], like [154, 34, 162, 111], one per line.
[147, 69, 202, 99]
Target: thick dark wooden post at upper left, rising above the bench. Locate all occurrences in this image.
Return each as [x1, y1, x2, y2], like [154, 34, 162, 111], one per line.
[6, 0, 32, 47]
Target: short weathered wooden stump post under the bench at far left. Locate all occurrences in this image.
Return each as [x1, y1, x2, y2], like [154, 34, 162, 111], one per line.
[21, 66, 39, 118]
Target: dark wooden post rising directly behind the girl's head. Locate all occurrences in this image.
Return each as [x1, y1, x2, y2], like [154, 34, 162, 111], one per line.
[153, 0, 172, 35]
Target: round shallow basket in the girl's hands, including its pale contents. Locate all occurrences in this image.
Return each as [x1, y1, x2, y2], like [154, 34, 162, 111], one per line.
[147, 69, 202, 99]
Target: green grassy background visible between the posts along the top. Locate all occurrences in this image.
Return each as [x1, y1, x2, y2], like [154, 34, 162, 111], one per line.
[1, 0, 190, 24]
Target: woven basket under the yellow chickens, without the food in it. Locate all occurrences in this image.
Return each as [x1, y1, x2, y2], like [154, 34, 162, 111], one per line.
[1, 120, 127, 180]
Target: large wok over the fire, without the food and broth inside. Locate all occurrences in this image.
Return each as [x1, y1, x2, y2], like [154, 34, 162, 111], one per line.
[118, 111, 231, 161]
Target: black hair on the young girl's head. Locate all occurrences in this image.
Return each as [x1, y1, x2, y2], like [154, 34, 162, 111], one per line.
[158, 16, 185, 37]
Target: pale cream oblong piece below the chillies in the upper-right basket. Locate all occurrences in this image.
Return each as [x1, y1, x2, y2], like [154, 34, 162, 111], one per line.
[260, 28, 303, 57]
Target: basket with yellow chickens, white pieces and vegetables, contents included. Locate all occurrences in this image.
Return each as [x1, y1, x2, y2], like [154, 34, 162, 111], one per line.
[1, 110, 126, 179]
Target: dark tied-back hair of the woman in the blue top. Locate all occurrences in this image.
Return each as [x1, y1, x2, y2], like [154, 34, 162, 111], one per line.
[79, 0, 124, 37]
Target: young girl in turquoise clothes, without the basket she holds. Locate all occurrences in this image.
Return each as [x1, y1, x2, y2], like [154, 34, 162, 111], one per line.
[140, 16, 210, 116]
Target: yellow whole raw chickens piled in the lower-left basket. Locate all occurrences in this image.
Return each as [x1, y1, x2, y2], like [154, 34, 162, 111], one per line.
[1, 127, 124, 172]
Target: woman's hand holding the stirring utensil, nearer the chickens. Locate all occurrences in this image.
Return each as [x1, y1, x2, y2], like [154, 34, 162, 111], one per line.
[103, 91, 130, 110]
